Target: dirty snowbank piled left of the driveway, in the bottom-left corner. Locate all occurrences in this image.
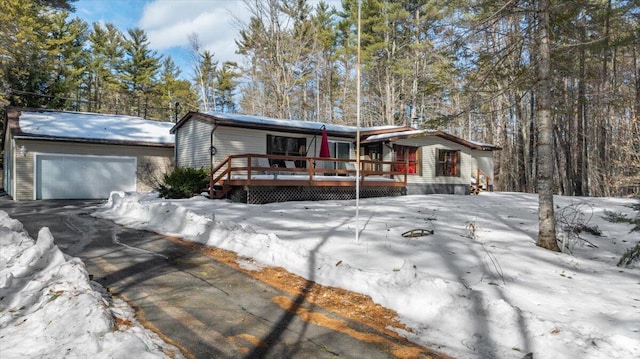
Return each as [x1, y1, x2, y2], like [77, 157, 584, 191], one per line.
[0, 211, 182, 359]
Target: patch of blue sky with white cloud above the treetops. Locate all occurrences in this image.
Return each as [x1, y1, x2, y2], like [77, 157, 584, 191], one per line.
[74, 0, 341, 79]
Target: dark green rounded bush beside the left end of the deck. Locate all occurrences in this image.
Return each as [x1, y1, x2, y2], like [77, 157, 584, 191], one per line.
[158, 167, 209, 198]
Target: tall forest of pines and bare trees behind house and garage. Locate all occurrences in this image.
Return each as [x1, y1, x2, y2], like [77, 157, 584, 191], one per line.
[0, 0, 640, 200]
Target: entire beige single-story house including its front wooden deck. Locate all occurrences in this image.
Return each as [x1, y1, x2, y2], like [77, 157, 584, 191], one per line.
[171, 112, 499, 203]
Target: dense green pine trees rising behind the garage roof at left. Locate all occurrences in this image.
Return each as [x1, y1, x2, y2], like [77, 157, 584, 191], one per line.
[0, 0, 197, 120]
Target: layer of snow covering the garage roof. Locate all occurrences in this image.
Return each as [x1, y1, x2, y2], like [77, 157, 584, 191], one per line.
[19, 111, 174, 144]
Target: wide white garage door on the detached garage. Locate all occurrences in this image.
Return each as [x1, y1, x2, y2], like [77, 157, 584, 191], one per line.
[35, 154, 136, 199]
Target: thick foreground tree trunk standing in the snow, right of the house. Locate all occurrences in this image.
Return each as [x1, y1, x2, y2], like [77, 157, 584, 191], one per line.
[536, 0, 560, 252]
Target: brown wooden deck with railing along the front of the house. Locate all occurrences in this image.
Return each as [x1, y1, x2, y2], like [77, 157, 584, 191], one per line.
[209, 154, 408, 198]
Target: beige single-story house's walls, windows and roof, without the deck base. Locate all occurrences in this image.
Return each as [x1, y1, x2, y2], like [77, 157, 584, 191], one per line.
[171, 112, 499, 202]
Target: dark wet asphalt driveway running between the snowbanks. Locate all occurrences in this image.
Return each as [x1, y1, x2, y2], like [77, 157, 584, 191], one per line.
[0, 199, 438, 358]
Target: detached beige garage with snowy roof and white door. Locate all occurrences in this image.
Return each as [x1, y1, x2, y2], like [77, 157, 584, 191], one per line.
[2, 107, 174, 200]
